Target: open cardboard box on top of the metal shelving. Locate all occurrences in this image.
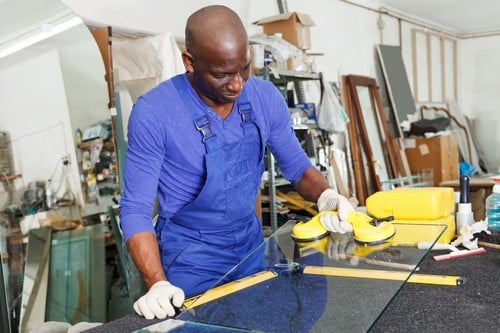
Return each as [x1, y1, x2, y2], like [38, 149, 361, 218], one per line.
[253, 12, 314, 50]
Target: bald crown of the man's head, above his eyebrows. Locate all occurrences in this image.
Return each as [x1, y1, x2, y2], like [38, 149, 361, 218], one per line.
[185, 5, 248, 53]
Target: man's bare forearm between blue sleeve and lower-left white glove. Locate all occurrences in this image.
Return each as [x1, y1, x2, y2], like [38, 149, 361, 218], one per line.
[127, 232, 166, 288]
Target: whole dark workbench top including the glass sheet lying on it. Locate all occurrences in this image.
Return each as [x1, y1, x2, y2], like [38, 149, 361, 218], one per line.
[84, 222, 500, 333]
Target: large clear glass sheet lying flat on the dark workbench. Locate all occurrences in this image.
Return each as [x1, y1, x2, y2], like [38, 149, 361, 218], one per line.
[169, 221, 446, 332]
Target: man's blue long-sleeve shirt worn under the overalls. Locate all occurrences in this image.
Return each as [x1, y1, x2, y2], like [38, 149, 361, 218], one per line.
[120, 74, 313, 241]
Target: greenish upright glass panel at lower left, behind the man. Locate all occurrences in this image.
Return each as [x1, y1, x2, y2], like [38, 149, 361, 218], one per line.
[46, 224, 107, 324]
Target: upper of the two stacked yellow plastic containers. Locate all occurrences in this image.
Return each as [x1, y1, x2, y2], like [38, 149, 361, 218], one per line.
[366, 187, 455, 220]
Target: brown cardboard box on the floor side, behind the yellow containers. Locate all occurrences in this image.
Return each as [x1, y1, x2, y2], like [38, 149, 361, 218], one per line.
[404, 135, 459, 186]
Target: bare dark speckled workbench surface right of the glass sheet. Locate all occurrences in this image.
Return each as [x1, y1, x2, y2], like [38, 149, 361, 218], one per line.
[370, 233, 500, 333]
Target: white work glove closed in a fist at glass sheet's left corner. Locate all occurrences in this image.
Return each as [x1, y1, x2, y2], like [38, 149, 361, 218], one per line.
[134, 281, 184, 319]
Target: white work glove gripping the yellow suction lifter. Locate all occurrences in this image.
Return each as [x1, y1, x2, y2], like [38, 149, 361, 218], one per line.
[317, 188, 354, 234]
